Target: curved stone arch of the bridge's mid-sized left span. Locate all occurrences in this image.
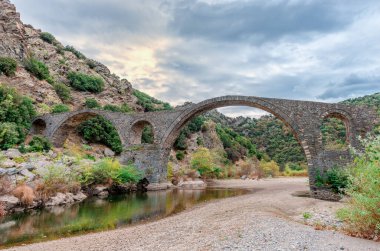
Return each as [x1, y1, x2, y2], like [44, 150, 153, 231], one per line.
[50, 110, 124, 147]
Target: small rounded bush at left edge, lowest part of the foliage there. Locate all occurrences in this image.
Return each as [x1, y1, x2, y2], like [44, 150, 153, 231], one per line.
[0, 122, 23, 150]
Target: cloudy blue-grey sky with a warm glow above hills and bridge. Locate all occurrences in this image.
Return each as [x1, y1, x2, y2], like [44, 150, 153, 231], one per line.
[11, 0, 380, 115]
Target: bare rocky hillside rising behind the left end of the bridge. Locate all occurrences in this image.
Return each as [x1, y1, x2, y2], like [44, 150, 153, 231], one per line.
[0, 0, 141, 111]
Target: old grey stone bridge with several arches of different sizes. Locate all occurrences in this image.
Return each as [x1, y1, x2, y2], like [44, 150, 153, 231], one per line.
[31, 96, 378, 192]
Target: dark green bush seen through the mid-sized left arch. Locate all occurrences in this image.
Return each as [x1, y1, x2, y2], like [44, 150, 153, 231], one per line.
[78, 116, 122, 154]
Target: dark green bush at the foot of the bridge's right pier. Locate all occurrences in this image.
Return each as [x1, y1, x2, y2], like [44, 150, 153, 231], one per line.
[315, 166, 348, 193]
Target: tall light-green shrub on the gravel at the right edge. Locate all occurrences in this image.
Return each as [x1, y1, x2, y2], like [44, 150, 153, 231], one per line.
[338, 136, 380, 239]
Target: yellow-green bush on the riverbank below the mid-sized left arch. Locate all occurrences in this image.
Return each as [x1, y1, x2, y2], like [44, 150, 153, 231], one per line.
[80, 158, 143, 186]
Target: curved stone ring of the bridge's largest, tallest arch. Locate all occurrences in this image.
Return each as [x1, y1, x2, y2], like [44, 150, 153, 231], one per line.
[162, 96, 313, 174]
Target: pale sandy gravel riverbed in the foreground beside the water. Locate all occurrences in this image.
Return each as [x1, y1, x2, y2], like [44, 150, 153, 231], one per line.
[3, 178, 380, 251]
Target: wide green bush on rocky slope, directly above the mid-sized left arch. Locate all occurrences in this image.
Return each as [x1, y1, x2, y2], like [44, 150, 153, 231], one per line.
[67, 71, 104, 93]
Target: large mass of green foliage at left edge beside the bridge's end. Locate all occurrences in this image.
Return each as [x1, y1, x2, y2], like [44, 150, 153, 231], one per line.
[0, 85, 36, 149]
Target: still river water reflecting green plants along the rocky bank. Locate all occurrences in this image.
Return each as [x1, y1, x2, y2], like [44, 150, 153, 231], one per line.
[0, 188, 249, 248]
